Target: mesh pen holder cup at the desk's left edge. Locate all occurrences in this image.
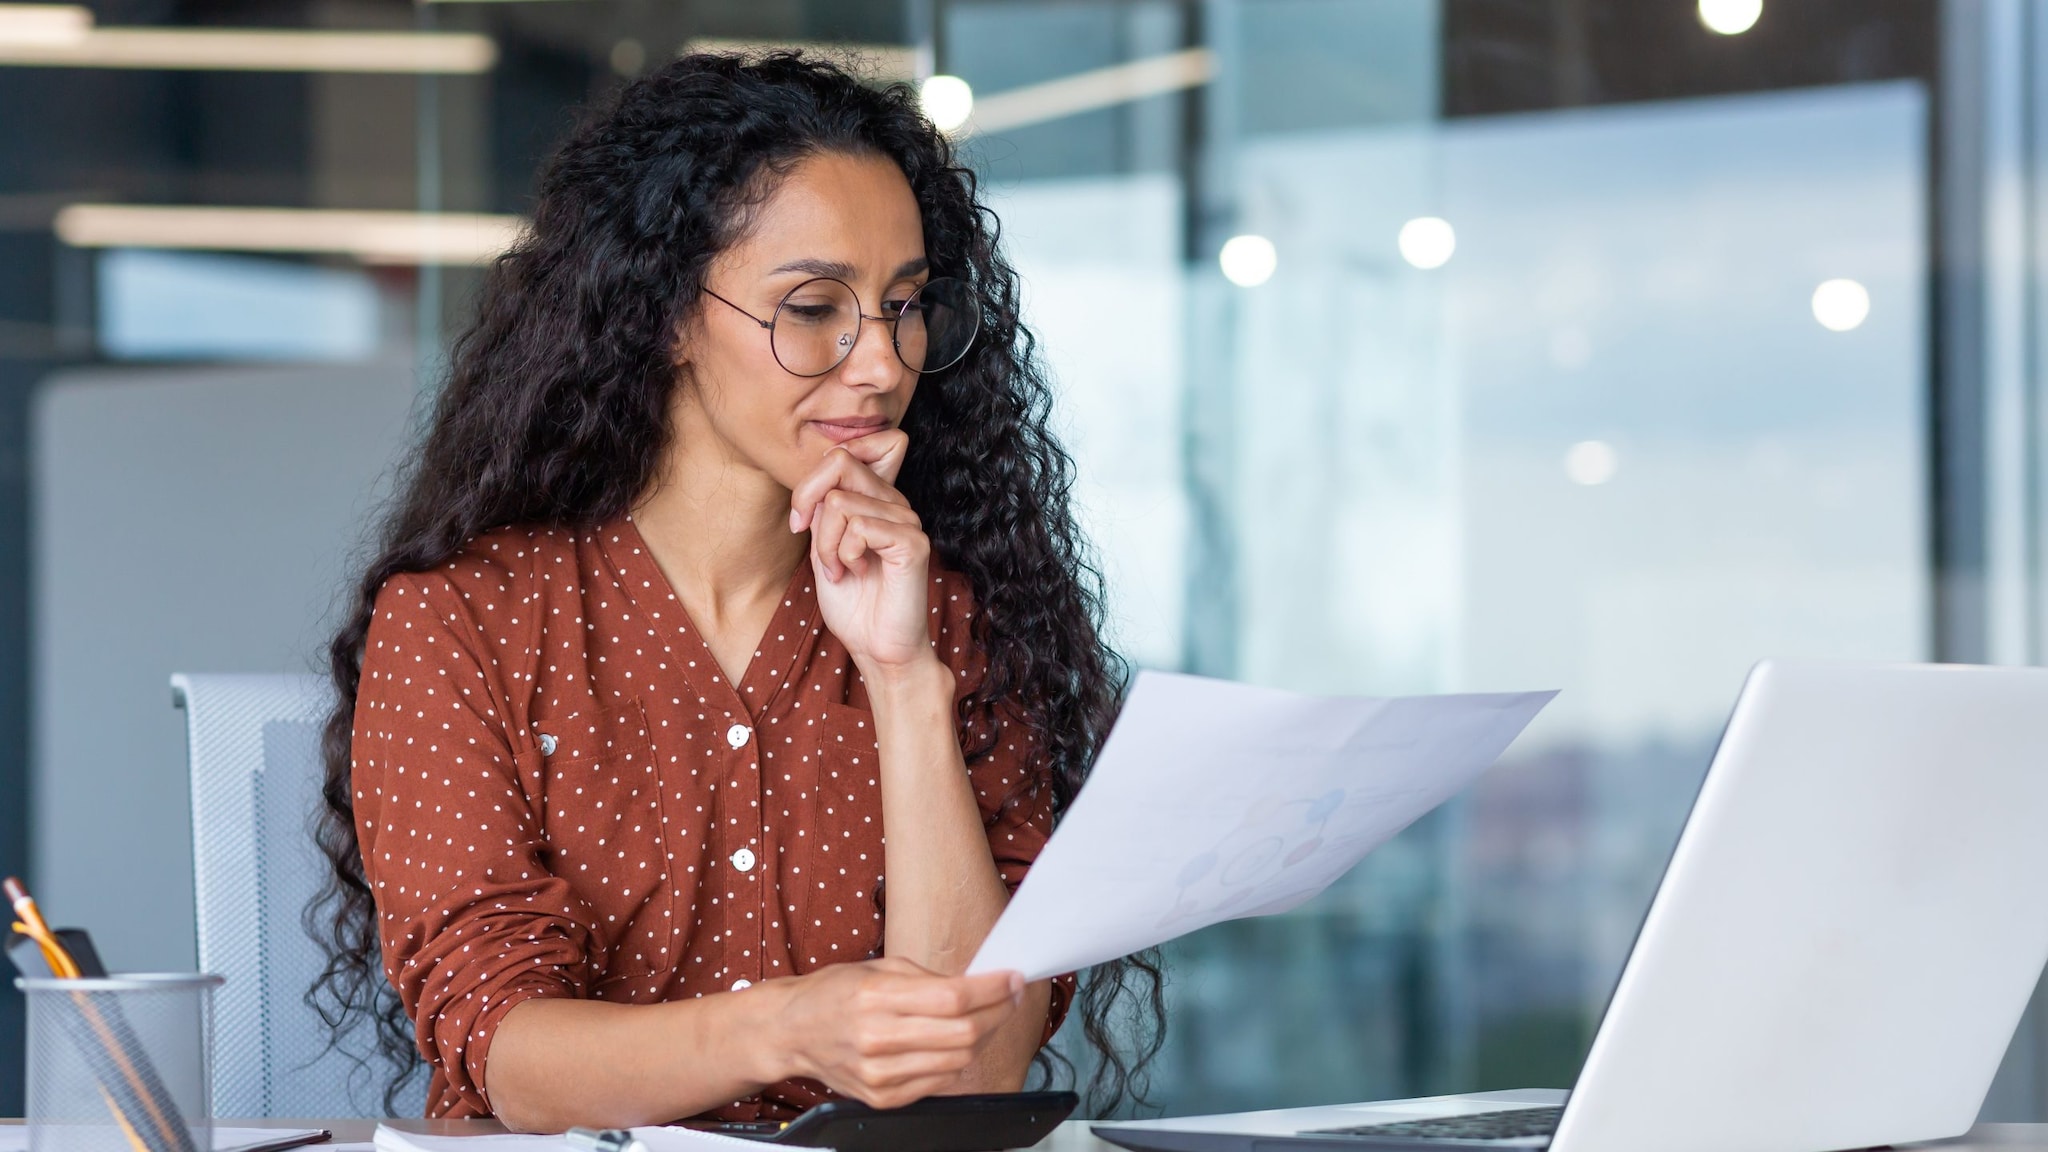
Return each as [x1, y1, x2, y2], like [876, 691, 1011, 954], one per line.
[14, 974, 221, 1152]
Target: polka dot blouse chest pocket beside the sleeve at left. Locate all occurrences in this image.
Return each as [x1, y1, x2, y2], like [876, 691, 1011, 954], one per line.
[530, 699, 674, 978]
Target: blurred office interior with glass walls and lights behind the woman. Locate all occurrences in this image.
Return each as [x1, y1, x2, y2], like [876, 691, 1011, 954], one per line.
[0, 0, 2048, 1119]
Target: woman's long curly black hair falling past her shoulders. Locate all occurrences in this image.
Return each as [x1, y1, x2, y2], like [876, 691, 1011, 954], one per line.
[307, 51, 1163, 1115]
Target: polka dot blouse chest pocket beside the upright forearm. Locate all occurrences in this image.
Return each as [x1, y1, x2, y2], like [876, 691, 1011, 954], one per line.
[797, 703, 883, 970]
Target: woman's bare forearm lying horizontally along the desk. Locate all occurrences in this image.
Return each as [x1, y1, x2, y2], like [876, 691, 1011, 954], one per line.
[483, 982, 786, 1132]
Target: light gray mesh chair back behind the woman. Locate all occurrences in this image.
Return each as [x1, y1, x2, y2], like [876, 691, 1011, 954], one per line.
[170, 674, 426, 1117]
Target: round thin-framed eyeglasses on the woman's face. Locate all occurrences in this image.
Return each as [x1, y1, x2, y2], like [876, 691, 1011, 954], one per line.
[705, 277, 981, 375]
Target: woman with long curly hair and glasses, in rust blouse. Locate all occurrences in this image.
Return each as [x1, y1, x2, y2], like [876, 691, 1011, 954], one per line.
[322, 53, 1157, 1129]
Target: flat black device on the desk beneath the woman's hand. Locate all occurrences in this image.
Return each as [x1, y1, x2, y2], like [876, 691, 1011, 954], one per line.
[688, 1093, 1081, 1152]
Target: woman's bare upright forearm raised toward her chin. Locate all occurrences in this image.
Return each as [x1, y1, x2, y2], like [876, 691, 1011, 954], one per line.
[864, 658, 1051, 1091]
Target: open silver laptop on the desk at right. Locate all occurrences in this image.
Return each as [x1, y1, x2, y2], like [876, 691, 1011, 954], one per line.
[1094, 662, 2048, 1152]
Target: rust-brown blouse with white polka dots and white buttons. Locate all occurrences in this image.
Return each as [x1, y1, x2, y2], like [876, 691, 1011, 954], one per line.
[352, 519, 1071, 1119]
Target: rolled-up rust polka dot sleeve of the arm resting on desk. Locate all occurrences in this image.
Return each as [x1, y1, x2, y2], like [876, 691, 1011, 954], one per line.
[352, 574, 600, 1115]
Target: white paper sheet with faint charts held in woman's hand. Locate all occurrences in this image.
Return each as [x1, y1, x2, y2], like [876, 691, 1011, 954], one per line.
[969, 672, 1556, 980]
